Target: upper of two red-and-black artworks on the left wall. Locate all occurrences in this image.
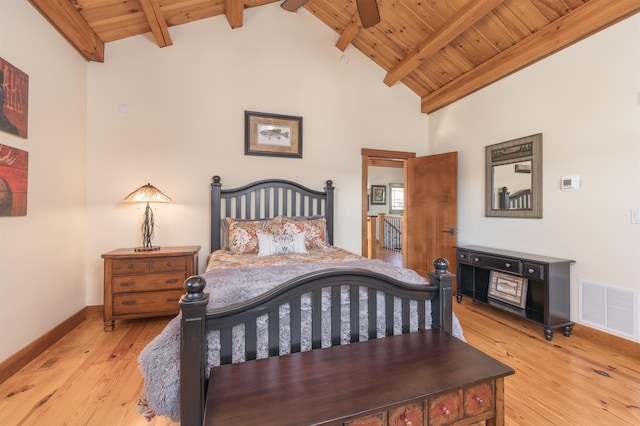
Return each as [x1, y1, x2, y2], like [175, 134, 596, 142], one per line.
[0, 58, 29, 139]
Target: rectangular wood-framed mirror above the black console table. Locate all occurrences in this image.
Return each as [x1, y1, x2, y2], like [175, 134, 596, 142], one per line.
[485, 133, 542, 218]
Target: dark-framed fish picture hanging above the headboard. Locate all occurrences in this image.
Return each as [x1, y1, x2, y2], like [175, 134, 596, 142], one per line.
[244, 111, 302, 158]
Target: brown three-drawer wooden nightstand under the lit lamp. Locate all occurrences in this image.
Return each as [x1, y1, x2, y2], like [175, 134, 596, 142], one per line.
[102, 246, 200, 331]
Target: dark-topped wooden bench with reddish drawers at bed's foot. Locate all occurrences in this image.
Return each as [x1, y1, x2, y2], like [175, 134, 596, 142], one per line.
[204, 330, 514, 426]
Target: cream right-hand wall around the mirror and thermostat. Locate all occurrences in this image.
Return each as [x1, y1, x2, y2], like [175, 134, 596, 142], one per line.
[429, 16, 640, 340]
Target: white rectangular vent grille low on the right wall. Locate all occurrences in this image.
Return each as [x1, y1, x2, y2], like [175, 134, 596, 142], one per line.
[579, 280, 639, 340]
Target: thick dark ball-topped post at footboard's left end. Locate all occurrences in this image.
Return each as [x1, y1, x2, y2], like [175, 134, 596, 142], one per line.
[180, 275, 209, 426]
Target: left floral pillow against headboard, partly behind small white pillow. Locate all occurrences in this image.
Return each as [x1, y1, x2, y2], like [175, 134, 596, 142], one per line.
[225, 216, 284, 254]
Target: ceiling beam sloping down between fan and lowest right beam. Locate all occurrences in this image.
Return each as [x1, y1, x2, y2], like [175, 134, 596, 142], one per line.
[384, 0, 504, 86]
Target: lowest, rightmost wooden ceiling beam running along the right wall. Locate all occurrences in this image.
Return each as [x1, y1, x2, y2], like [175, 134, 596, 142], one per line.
[421, 0, 640, 114]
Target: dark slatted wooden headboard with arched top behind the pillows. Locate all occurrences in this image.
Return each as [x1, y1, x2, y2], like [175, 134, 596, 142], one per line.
[211, 176, 334, 251]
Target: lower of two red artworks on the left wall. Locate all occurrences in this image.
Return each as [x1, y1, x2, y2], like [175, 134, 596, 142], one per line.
[0, 145, 29, 216]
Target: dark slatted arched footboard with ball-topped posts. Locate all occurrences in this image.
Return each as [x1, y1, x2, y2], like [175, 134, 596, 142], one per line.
[180, 259, 453, 426]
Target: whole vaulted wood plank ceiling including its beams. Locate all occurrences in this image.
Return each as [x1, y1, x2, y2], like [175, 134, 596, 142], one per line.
[29, 0, 640, 113]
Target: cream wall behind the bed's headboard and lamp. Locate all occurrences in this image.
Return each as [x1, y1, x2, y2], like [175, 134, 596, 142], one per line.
[82, 3, 428, 305]
